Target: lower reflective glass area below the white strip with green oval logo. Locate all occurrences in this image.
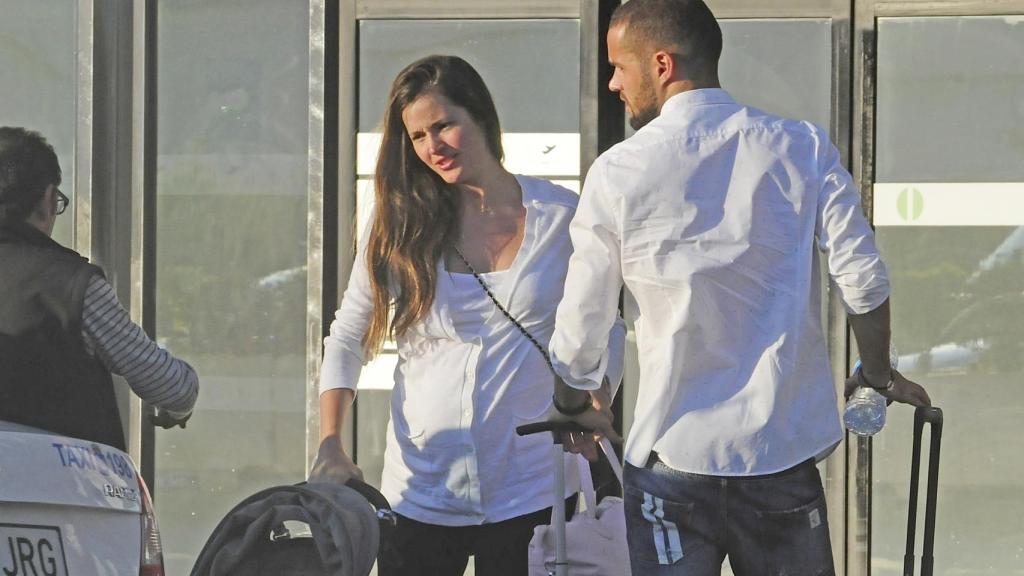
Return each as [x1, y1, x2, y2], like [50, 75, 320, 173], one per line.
[871, 227, 1024, 574]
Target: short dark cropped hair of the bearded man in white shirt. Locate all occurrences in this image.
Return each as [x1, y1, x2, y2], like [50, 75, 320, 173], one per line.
[610, 0, 722, 81]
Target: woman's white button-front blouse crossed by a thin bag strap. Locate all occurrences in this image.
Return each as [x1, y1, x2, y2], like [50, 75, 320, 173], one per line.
[319, 176, 626, 526]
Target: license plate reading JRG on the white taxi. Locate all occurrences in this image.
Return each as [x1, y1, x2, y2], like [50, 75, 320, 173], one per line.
[0, 523, 68, 576]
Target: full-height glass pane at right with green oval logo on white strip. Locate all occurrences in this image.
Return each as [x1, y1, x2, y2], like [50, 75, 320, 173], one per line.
[871, 16, 1024, 574]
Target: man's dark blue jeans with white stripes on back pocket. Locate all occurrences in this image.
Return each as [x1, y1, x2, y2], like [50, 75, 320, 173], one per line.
[624, 453, 836, 576]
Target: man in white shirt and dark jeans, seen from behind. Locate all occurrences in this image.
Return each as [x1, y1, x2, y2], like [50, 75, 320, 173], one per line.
[551, 0, 930, 575]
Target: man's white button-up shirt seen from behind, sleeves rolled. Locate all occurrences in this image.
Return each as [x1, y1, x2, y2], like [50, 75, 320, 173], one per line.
[551, 89, 889, 476]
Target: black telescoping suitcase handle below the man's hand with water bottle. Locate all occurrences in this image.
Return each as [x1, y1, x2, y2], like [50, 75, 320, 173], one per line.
[903, 406, 942, 576]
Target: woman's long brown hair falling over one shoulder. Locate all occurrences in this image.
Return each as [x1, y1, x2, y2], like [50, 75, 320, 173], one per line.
[362, 55, 504, 359]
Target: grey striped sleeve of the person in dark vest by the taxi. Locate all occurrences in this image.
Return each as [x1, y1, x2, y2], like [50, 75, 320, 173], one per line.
[82, 276, 199, 416]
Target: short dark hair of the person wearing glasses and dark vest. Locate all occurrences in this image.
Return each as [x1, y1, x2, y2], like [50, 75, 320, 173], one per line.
[0, 126, 60, 220]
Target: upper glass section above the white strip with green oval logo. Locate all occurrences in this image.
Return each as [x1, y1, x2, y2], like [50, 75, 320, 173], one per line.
[876, 16, 1024, 182]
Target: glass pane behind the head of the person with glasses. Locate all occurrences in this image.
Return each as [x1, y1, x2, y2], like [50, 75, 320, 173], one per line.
[0, 0, 77, 242]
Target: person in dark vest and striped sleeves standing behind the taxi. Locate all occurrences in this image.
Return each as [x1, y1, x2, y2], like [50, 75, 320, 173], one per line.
[0, 126, 199, 450]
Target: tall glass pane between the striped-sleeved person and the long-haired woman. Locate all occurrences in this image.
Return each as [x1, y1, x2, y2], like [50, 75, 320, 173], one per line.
[156, 0, 309, 574]
